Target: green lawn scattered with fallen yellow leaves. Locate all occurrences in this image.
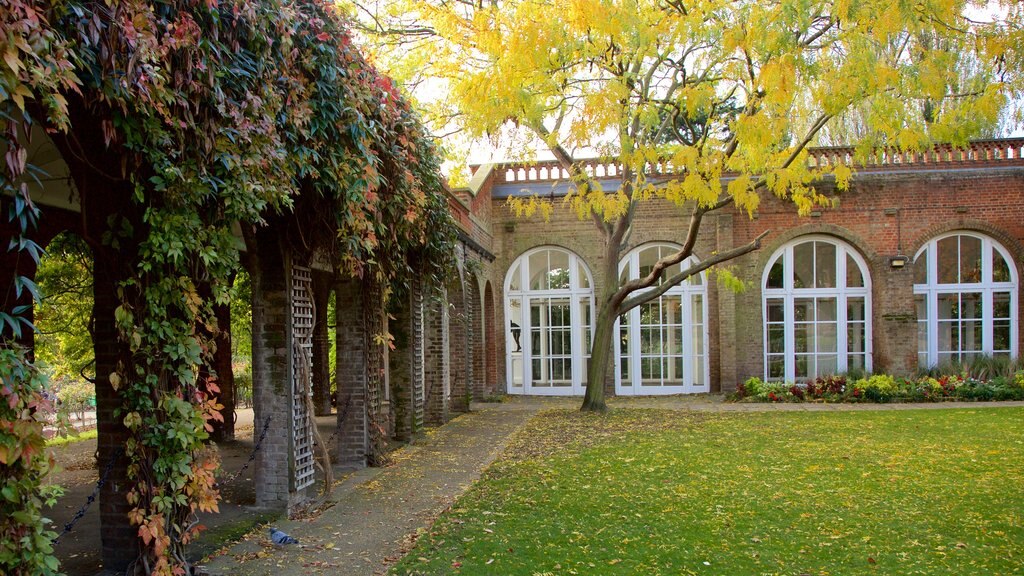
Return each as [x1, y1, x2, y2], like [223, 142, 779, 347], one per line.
[394, 408, 1024, 575]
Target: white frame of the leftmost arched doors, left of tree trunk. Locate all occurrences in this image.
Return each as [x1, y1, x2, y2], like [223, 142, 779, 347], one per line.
[504, 246, 594, 396]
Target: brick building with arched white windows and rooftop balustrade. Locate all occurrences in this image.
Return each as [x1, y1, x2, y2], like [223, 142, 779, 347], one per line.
[457, 139, 1024, 396]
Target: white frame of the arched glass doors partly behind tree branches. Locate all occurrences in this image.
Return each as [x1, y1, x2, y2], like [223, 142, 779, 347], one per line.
[613, 242, 711, 396]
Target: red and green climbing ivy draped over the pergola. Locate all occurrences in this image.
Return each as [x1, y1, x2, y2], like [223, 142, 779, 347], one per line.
[0, 0, 454, 574]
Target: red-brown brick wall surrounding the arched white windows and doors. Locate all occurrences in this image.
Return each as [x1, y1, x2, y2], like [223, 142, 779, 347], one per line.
[484, 162, 1024, 390]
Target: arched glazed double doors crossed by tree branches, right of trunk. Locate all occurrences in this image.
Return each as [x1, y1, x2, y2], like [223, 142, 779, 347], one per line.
[615, 244, 710, 395]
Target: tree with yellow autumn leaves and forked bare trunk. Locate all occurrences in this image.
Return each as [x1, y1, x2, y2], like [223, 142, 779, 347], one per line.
[353, 0, 1021, 411]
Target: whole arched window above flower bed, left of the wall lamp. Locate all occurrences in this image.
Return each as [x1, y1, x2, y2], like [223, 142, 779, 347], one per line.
[761, 236, 871, 381]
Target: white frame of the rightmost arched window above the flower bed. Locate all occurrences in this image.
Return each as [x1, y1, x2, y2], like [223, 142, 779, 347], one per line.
[913, 230, 1020, 368]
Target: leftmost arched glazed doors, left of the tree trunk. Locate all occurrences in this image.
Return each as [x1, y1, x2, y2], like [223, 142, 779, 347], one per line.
[505, 247, 594, 396]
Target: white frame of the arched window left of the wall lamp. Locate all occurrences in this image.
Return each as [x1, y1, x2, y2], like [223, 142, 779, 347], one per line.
[761, 234, 872, 382]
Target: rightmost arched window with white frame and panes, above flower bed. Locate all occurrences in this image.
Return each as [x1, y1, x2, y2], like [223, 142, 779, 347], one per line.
[913, 232, 1018, 367]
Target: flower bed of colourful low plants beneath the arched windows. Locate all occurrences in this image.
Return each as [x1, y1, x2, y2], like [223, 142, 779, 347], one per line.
[729, 370, 1024, 402]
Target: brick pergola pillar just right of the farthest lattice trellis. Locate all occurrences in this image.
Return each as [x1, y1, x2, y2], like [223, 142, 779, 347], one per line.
[423, 290, 451, 425]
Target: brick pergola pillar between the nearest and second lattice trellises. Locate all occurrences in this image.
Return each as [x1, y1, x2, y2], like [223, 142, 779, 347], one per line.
[335, 279, 369, 468]
